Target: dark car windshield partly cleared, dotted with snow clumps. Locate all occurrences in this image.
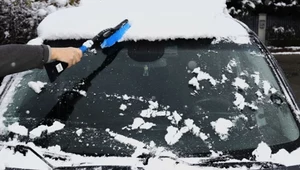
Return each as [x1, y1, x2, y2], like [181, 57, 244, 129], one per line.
[2, 39, 299, 156]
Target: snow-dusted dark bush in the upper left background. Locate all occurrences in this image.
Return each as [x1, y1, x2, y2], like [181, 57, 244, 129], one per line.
[0, 0, 79, 44]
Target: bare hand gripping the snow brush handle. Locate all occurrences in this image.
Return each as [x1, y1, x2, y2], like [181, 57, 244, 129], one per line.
[51, 47, 82, 68]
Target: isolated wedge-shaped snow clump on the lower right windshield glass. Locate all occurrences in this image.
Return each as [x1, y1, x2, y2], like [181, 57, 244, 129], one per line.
[210, 118, 234, 140]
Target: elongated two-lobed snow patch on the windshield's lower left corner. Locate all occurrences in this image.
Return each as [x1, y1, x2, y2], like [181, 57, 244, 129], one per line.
[29, 121, 65, 138]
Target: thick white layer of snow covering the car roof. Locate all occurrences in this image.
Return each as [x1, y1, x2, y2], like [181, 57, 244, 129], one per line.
[38, 0, 249, 43]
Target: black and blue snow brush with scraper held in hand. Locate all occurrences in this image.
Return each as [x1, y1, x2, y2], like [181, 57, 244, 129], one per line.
[44, 19, 130, 83]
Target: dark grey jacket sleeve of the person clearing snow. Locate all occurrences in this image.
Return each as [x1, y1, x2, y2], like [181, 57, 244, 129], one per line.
[0, 44, 51, 77]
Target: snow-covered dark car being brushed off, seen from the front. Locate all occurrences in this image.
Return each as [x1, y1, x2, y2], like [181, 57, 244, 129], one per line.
[0, 0, 300, 169]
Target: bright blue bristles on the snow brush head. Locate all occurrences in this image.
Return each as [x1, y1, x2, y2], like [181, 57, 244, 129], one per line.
[101, 23, 130, 48]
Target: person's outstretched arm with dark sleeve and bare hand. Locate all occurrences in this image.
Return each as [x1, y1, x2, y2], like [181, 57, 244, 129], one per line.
[0, 44, 82, 77]
